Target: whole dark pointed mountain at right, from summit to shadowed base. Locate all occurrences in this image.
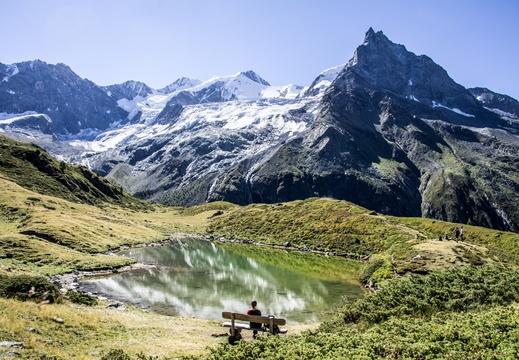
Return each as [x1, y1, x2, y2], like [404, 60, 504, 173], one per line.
[202, 29, 519, 231]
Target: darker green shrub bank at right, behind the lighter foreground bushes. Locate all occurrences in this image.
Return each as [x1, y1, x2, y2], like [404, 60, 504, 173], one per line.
[344, 266, 519, 323]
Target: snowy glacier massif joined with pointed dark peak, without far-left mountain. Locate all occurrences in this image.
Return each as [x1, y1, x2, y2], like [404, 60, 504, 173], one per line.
[0, 29, 519, 230]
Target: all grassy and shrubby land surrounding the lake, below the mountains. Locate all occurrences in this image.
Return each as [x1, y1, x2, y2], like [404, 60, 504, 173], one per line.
[0, 134, 519, 360]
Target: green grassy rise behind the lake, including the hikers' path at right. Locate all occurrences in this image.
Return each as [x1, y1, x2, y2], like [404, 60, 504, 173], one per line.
[208, 198, 519, 281]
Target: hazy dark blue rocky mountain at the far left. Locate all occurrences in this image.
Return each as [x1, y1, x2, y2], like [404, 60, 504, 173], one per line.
[0, 60, 128, 134]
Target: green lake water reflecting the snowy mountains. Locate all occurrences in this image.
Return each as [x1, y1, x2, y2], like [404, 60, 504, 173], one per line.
[81, 239, 362, 323]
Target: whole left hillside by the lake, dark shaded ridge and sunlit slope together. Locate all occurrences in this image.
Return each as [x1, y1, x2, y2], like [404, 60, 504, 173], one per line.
[0, 136, 217, 275]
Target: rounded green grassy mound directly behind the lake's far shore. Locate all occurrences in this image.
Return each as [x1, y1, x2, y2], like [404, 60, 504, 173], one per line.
[208, 199, 417, 258]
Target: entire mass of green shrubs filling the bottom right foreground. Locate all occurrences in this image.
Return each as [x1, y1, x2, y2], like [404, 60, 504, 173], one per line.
[204, 267, 519, 360]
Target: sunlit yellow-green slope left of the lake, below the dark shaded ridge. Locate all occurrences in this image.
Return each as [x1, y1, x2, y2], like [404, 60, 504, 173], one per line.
[0, 174, 221, 275]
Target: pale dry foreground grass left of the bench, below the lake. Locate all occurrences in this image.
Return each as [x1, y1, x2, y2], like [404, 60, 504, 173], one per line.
[0, 298, 222, 359]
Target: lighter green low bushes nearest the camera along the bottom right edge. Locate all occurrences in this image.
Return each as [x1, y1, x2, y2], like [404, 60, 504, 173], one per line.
[203, 306, 519, 360]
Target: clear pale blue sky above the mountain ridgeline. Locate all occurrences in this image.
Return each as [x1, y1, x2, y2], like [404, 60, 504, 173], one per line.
[0, 0, 519, 98]
